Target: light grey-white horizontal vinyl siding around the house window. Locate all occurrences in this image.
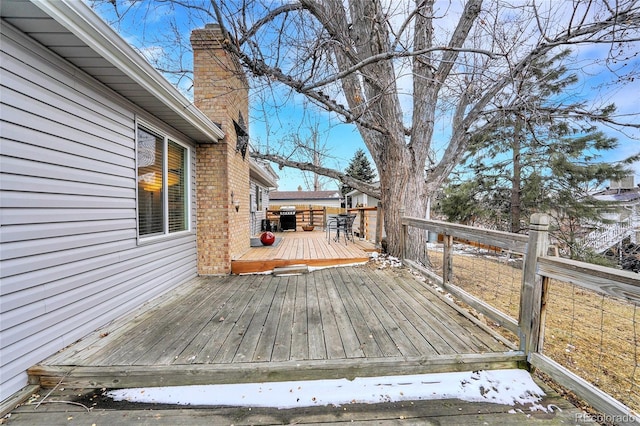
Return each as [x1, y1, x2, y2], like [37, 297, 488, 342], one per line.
[0, 22, 197, 400]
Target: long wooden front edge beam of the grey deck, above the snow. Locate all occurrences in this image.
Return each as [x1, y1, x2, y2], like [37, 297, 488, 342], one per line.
[29, 351, 526, 388]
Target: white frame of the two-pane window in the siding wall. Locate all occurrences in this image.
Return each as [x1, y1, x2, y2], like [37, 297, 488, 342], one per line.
[134, 119, 193, 244]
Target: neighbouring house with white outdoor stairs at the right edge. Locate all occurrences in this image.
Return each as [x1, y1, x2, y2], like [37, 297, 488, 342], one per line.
[585, 176, 640, 252]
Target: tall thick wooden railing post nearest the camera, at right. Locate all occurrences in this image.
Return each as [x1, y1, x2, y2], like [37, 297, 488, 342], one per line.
[519, 213, 549, 356]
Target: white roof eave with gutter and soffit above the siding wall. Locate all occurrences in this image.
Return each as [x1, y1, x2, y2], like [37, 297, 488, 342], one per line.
[0, 0, 224, 143]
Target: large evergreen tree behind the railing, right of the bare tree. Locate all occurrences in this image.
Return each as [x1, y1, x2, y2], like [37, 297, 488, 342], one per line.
[443, 51, 625, 245]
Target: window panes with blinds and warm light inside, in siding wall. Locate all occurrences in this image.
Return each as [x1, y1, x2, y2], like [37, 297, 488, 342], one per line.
[137, 126, 189, 237]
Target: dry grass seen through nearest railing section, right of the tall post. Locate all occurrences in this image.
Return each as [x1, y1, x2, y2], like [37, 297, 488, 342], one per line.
[543, 280, 640, 411]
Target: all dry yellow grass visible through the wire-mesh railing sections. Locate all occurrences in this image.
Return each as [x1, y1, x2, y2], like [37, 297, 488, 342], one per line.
[422, 245, 640, 412]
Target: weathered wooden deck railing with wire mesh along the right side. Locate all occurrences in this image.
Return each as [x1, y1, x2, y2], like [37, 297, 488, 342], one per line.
[402, 214, 640, 424]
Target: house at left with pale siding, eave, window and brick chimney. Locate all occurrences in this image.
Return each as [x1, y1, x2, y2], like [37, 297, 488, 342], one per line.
[0, 0, 262, 400]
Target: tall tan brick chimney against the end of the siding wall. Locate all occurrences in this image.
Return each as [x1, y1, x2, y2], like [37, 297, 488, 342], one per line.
[191, 24, 251, 275]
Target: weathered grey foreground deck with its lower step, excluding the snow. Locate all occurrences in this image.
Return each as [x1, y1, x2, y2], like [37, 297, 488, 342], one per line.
[15, 263, 587, 425]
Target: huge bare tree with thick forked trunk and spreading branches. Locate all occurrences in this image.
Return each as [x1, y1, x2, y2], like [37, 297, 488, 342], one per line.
[91, 0, 640, 262]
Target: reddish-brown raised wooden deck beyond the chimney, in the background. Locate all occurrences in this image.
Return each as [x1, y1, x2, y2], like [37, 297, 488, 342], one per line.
[231, 229, 376, 274]
